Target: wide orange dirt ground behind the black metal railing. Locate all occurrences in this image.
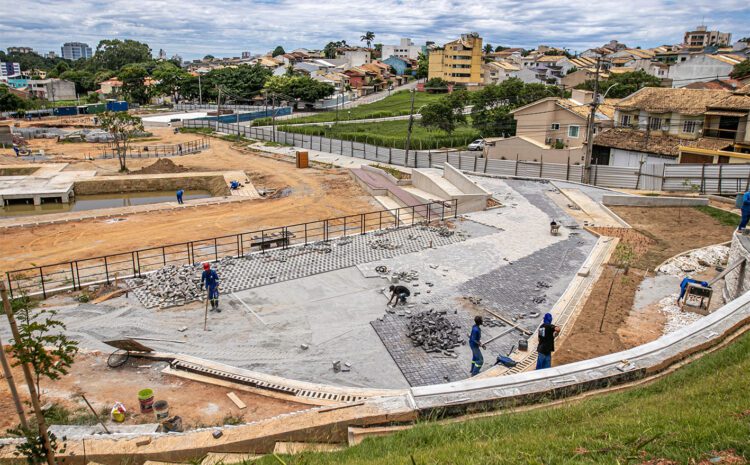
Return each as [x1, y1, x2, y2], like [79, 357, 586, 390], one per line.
[0, 129, 382, 271]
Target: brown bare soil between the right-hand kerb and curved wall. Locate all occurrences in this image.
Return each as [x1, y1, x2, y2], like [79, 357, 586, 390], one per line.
[554, 207, 734, 365]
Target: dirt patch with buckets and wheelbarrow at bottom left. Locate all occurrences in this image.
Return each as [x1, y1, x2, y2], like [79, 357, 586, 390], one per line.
[0, 354, 309, 437]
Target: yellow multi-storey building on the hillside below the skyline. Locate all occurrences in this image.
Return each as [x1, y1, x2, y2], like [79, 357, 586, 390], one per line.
[427, 32, 482, 86]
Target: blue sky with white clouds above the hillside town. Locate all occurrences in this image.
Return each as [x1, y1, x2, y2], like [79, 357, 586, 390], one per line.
[0, 0, 750, 59]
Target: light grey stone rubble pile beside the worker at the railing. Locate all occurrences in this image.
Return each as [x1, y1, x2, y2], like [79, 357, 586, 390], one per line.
[133, 257, 234, 308]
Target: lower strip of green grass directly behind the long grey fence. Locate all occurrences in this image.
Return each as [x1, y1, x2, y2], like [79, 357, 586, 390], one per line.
[279, 120, 479, 150]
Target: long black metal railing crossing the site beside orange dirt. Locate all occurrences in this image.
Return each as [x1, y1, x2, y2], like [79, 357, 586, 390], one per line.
[6, 200, 458, 298]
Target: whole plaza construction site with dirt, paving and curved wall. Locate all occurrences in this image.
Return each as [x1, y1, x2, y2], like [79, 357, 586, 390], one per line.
[0, 113, 750, 465]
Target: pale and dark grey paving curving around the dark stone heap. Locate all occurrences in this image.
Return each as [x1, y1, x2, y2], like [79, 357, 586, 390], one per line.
[372, 177, 596, 386]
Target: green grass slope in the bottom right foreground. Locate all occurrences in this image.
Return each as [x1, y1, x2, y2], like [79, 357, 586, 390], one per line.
[248, 334, 750, 465]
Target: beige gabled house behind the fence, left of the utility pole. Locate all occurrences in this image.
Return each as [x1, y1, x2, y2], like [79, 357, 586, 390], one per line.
[486, 89, 615, 164]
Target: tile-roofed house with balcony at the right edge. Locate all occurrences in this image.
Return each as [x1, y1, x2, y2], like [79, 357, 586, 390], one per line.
[593, 85, 750, 166]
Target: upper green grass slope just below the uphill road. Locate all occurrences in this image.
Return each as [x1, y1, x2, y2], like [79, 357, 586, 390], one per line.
[253, 91, 445, 126]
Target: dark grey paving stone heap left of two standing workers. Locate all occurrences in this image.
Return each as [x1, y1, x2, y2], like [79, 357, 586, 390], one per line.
[406, 309, 466, 355]
